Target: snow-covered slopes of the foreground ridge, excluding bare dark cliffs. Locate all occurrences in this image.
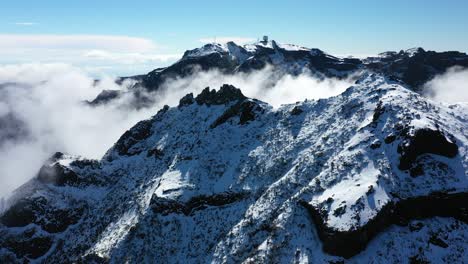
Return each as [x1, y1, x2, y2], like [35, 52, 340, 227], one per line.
[0, 74, 468, 263]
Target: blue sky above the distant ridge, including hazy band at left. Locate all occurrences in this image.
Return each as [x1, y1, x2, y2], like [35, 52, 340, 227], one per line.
[0, 0, 468, 74]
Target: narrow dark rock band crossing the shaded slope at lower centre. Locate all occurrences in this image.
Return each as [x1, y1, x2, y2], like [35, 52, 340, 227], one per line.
[150, 192, 247, 215]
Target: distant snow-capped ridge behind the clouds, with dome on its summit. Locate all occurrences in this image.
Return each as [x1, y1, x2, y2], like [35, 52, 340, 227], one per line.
[87, 40, 468, 105]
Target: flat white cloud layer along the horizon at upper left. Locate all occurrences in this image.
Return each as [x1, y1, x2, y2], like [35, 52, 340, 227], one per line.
[0, 34, 180, 75]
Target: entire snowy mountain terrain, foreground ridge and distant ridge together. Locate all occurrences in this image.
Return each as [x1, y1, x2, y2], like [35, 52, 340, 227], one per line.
[0, 42, 468, 263]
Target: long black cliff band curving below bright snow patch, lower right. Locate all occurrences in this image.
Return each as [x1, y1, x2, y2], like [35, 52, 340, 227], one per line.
[301, 193, 468, 258]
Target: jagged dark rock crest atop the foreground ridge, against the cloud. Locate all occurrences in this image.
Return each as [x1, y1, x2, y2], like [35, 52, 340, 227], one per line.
[195, 84, 247, 105]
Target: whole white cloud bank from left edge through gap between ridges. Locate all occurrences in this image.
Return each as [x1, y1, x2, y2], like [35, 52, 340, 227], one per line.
[0, 64, 351, 197]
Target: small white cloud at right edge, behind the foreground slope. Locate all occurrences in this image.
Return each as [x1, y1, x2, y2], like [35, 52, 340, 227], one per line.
[424, 67, 468, 103]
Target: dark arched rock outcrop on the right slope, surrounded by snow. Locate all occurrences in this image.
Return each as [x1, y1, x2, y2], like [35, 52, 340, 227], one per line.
[398, 129, 458, 170]
